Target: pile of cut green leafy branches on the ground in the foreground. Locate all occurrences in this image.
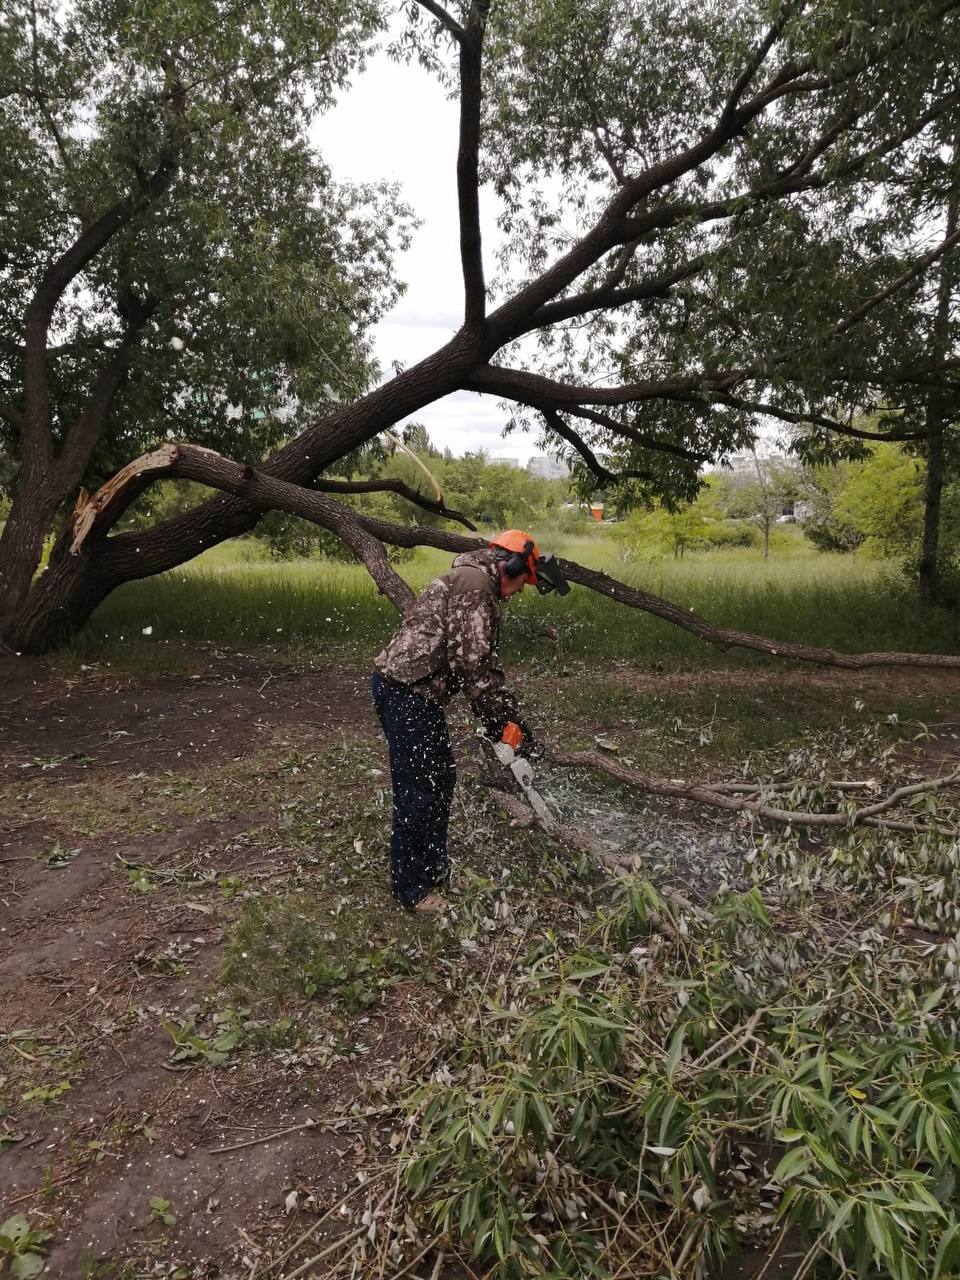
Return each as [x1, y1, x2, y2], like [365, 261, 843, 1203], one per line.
[403, 797, 960, 1280]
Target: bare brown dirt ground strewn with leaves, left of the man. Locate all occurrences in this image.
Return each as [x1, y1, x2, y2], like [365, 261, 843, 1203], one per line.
[0, 659, 419, 1277]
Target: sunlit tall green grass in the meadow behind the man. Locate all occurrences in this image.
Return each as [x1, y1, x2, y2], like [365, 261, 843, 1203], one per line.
[76, 530, 960, 666]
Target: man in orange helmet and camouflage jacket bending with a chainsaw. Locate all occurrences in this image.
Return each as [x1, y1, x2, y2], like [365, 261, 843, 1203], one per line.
[372, 529, 570, 915]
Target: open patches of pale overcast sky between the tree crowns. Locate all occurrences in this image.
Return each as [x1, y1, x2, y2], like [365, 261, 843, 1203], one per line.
[314, 54, 538, 461]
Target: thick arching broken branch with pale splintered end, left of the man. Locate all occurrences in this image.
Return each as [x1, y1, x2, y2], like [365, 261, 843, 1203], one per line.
[70, 444, 413, 613]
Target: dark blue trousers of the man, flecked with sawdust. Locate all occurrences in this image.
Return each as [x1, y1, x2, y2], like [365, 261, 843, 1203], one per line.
[371, 672, 457, 909]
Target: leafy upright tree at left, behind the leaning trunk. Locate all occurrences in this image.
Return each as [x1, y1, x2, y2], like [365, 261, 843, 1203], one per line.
[0, 0, 404, 634]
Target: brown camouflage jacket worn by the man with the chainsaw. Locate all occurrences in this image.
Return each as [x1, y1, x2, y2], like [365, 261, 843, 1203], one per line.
[374, 550, 527, 737]
